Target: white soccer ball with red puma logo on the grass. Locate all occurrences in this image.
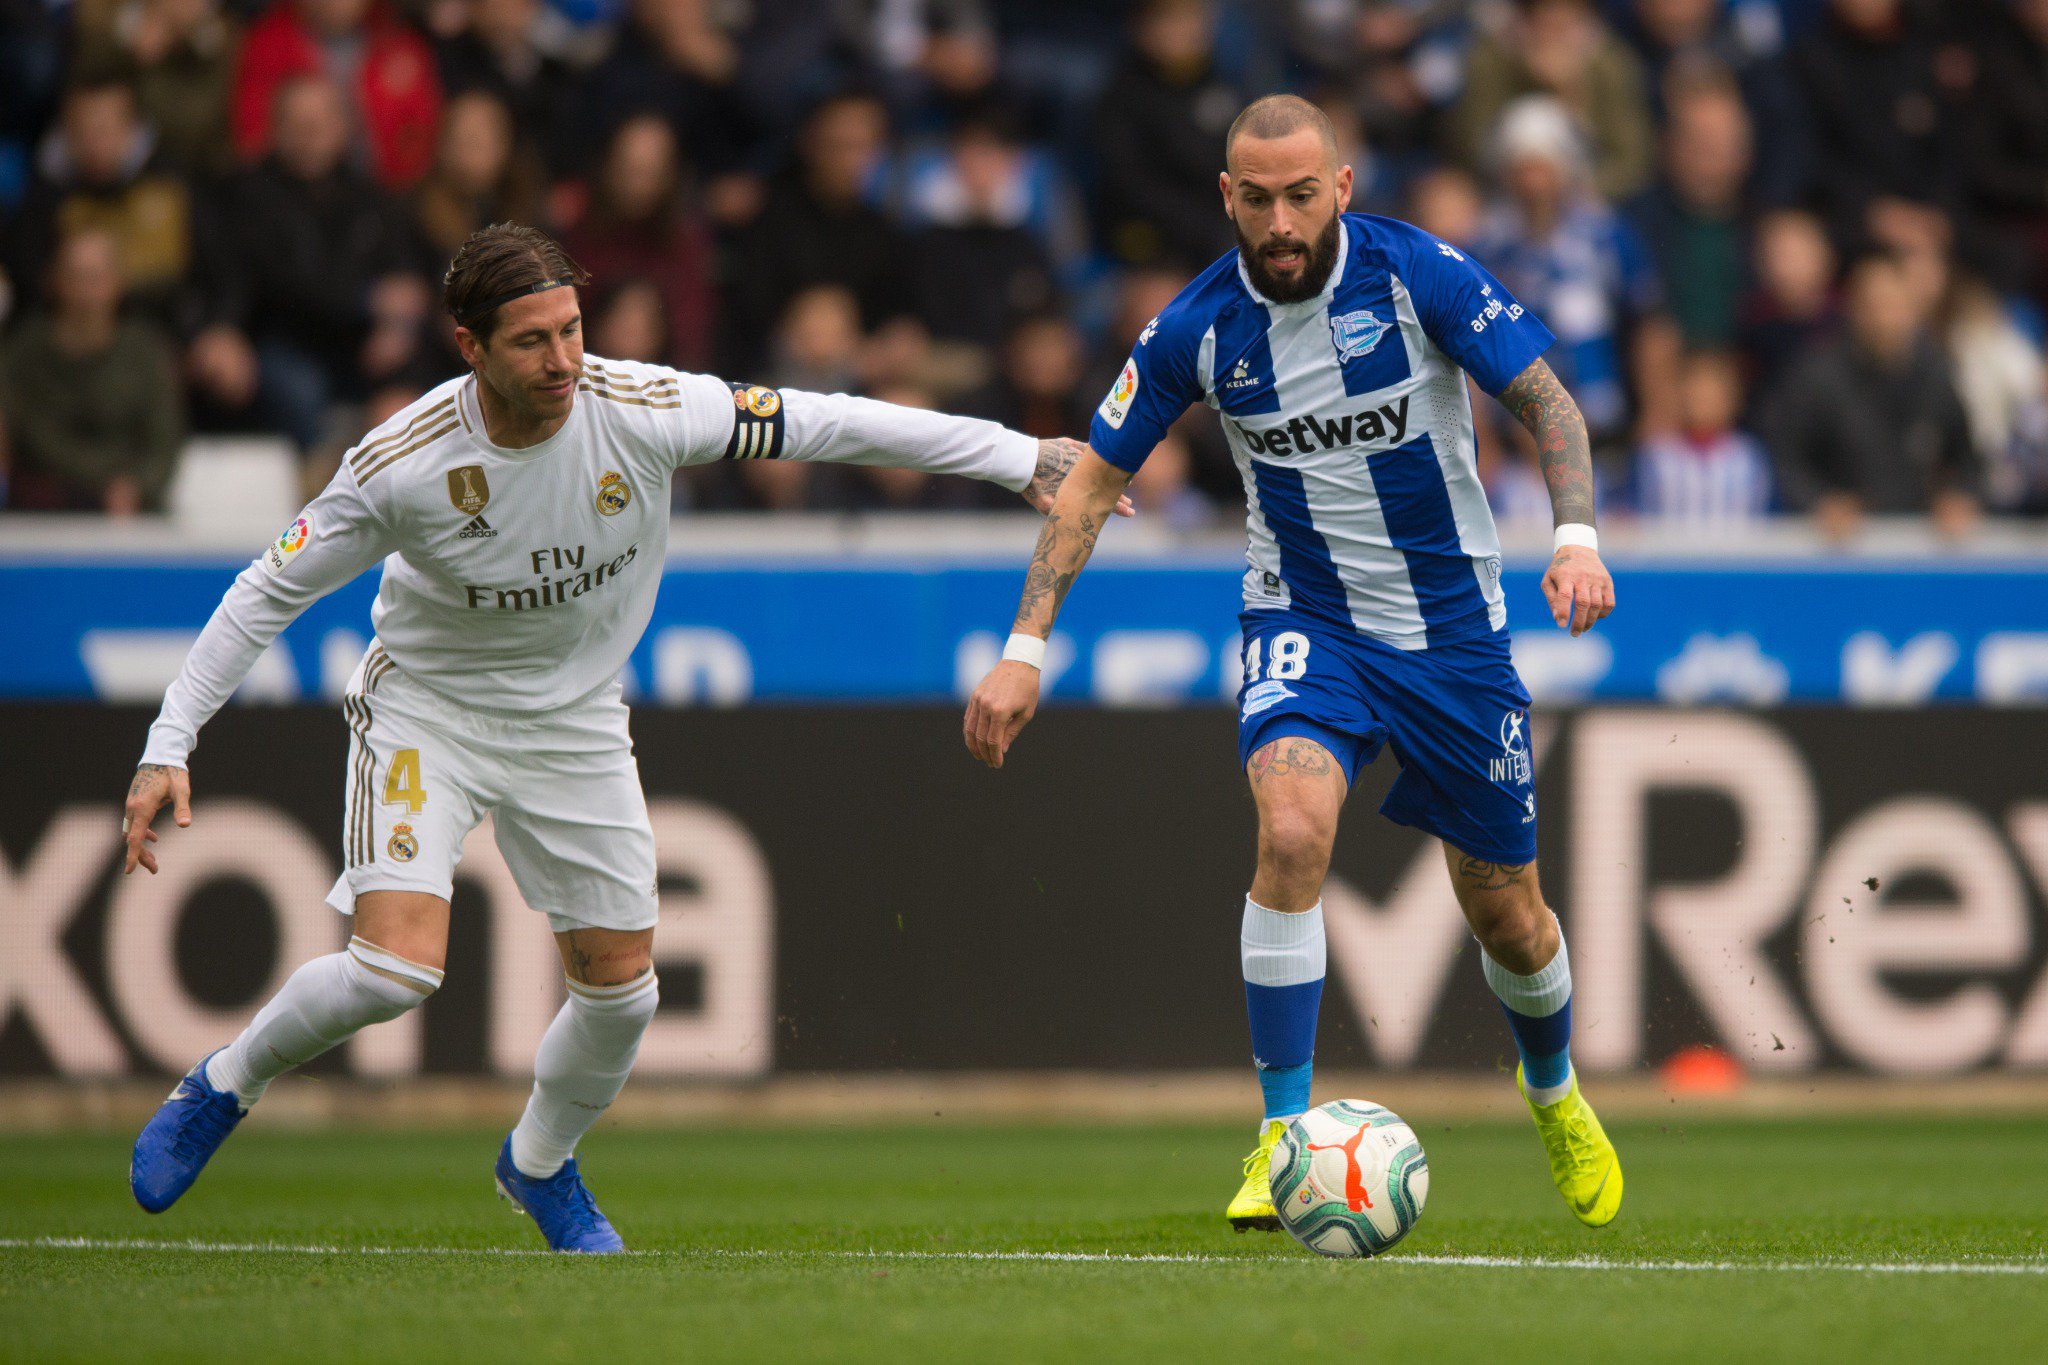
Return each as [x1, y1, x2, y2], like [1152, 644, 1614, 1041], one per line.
[1272, 1099, 1430, 1259]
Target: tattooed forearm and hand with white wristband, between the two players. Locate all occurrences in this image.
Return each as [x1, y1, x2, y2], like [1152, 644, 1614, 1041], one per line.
[961, 440, 1130, 767]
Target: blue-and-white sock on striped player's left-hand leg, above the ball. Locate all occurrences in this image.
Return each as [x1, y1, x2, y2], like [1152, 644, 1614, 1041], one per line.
[1237, 896, 1327, 1119]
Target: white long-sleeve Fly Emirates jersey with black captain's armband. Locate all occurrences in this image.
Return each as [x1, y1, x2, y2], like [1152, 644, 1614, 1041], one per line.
[141, 356, 1038, 767]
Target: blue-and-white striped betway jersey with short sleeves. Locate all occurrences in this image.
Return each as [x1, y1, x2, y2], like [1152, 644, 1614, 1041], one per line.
[1090, 213, 1552, 649]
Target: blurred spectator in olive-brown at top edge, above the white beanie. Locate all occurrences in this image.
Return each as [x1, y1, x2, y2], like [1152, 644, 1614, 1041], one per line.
[1450, 0, 1653, 203]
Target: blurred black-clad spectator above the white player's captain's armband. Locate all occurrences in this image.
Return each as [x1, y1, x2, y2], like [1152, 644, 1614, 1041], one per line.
[725, 94, 911, 372]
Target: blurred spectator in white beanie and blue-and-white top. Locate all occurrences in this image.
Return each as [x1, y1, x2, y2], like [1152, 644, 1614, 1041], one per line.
[1473, 94, 1677, 446]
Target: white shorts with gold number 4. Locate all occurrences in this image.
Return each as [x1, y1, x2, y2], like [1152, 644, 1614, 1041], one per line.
[328, 643, 657, 933]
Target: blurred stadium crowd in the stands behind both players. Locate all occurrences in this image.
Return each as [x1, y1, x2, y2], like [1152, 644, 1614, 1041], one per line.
[0, 0, 2048, 538]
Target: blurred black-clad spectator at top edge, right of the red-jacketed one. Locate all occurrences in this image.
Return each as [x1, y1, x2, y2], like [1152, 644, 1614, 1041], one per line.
[436, 0, 578, 174]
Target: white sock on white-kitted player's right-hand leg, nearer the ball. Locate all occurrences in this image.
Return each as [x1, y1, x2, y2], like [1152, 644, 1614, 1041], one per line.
[512, 972, 662, 1181]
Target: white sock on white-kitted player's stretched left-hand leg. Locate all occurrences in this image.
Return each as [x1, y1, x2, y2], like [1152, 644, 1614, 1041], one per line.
[207, 939, 440, 1109]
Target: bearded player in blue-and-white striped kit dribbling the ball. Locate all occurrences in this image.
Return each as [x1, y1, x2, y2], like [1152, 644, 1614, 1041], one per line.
[965, 96, 1622, 1230]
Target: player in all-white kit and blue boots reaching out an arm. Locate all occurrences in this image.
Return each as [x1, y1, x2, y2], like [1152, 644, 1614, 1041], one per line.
[123, 225, 1128, 1252]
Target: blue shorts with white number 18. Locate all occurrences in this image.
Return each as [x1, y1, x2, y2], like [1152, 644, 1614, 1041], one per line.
[1237, 612, 1536, 864]
